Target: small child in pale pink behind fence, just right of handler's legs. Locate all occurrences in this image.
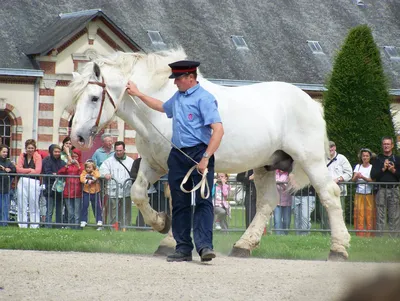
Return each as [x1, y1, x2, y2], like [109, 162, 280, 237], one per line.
[214, 173, 231, 231]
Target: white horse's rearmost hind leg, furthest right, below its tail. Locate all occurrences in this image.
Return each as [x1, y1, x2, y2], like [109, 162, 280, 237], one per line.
[303, 160, 350, 260]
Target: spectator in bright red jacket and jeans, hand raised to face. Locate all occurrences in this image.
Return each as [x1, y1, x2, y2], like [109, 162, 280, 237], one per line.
[58, 148, 84, 229]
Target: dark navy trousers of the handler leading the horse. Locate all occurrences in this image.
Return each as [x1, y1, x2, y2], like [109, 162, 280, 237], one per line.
[168, 144, 214, 254]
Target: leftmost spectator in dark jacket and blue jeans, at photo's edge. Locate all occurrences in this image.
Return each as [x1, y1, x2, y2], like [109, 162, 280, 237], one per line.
[0, 144, 17, 226]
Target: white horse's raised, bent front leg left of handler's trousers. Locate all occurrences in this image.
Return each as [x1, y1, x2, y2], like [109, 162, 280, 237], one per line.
[131, 158, 171, 234]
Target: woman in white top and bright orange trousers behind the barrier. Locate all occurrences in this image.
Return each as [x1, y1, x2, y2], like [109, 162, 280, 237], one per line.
[352, 148, 375, 237]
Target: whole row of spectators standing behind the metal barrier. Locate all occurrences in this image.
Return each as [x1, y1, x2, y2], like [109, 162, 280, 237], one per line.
[0, 134, 400, 237]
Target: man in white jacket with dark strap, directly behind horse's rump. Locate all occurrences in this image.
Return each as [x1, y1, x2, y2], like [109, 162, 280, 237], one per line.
[321, 141, 353, 229]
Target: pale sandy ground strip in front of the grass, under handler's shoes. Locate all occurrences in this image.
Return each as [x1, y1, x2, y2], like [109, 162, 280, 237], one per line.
[0, 250, 400, 301]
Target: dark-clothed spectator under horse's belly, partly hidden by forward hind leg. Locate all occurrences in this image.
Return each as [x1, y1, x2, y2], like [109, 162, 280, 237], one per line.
[236, 170, 257, 229]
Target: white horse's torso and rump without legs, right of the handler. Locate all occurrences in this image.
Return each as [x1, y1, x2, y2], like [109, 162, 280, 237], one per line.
[198, 78, 325, 171]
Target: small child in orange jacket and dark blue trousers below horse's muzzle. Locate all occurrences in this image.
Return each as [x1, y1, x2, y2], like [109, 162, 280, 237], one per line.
[80, 159, 103, 230]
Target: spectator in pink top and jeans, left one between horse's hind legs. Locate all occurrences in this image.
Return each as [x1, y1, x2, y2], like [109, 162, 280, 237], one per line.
[274, 169, 292, 235]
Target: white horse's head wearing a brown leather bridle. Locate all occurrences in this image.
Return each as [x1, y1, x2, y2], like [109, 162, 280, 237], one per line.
[70, 62, 126, 148]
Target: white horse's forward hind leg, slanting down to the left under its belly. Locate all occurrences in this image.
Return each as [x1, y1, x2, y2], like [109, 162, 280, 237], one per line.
[229, 167, 278, 257]
